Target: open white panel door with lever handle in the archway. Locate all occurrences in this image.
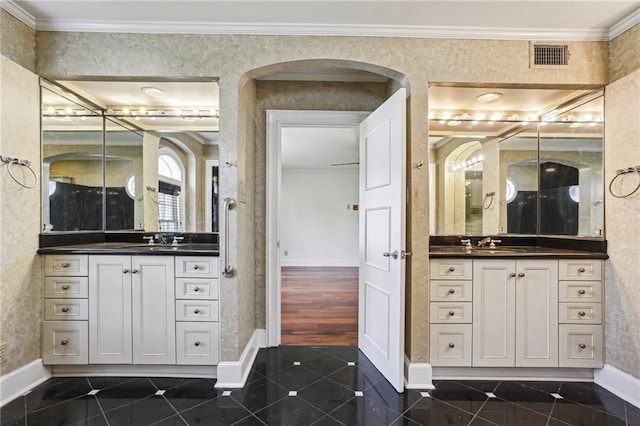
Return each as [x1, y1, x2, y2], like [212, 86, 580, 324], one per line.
[358, 89, 406, 392]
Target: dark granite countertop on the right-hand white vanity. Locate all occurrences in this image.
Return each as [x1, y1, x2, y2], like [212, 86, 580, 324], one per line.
[429, 245, 609, 259]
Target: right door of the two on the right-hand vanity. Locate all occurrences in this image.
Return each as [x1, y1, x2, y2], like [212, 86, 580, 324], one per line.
[515, 260, 558, 367]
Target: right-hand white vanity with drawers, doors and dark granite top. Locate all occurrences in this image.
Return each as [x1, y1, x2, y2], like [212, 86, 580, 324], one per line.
[429, 241, 606, 374]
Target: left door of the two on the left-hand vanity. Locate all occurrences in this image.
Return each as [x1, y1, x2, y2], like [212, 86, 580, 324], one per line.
[89, 256, 132, 364]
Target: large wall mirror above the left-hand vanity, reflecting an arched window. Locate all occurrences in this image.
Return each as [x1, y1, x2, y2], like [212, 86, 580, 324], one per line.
[41, 80, 219, 233]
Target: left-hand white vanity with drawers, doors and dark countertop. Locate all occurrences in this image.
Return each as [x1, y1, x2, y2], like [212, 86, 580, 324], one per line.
[39, 243, 220, 372]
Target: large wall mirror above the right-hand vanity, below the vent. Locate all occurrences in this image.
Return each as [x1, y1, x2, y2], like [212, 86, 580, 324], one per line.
[429, 86, 604, 238]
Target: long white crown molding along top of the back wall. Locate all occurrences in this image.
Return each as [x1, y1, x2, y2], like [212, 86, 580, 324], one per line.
[28, 20, 609, 41]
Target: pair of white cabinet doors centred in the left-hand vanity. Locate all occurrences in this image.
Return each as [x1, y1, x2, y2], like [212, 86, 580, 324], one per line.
[89, 255, 175, 364]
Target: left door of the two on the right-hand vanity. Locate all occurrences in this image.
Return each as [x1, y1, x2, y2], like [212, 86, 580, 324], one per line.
[473, 259, 516, 367]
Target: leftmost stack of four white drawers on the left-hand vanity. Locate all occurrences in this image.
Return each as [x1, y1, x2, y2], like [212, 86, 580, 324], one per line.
[42, 255, 89, 365]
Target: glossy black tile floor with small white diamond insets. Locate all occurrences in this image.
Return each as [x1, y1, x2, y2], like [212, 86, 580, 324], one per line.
[0, 346, 640, 426]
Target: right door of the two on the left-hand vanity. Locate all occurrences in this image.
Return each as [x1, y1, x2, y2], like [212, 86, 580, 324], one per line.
[131, 256, 176, 364]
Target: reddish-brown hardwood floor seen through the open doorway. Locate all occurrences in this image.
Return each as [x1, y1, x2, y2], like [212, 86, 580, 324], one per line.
[281, 267, 358, 346]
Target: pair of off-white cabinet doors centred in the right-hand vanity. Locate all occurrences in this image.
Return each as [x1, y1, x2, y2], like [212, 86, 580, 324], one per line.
[473, 259, 558, 367]
